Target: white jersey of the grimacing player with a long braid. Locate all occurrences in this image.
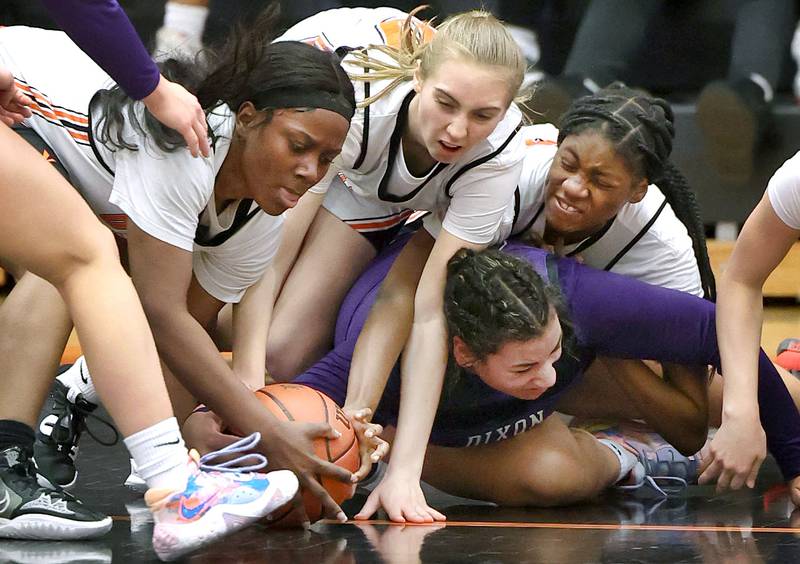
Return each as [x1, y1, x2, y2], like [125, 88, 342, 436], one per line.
[496, 124, 703, 296]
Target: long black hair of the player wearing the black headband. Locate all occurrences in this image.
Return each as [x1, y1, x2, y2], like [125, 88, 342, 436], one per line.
[92, 2, 356, 151]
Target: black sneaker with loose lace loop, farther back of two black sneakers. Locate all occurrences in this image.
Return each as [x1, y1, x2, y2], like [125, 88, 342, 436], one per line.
[33, 380, 119, 490]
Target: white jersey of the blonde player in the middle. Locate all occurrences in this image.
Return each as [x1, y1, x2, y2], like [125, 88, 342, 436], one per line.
[280, 8, 523, 244]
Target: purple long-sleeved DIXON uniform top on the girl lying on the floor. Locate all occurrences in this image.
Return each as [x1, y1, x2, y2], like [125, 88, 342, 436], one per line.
[295, 234, 800, 480]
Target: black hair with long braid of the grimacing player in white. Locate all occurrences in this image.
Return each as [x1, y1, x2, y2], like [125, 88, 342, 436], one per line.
[558, 83, 716, 301]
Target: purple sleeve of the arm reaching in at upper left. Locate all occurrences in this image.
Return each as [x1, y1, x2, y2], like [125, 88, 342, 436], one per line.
[42, 0, 160, 100]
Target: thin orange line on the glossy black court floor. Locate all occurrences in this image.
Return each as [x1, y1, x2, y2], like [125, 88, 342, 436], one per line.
[321, 519, 800, 534]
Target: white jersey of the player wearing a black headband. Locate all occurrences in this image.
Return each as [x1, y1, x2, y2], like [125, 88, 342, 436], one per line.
[0, 27, 283, 302]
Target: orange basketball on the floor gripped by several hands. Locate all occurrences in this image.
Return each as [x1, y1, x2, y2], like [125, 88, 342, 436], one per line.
[255, 384, 360, 523]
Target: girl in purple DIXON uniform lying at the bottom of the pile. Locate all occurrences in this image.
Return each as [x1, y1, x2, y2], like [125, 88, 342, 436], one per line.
[276, 231, 800, 521]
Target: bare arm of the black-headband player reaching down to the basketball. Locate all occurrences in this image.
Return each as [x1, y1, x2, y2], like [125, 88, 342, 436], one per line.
[128, 221, 351, 519]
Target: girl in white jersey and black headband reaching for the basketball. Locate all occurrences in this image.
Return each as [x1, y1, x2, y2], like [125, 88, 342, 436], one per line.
[0, 6, 355, 518]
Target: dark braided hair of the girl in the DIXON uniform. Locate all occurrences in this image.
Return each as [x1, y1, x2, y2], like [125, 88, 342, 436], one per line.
[444, 249, 571, 384]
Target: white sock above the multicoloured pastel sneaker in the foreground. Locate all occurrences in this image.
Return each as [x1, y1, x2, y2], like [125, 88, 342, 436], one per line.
[125, 417, 189, 490]
